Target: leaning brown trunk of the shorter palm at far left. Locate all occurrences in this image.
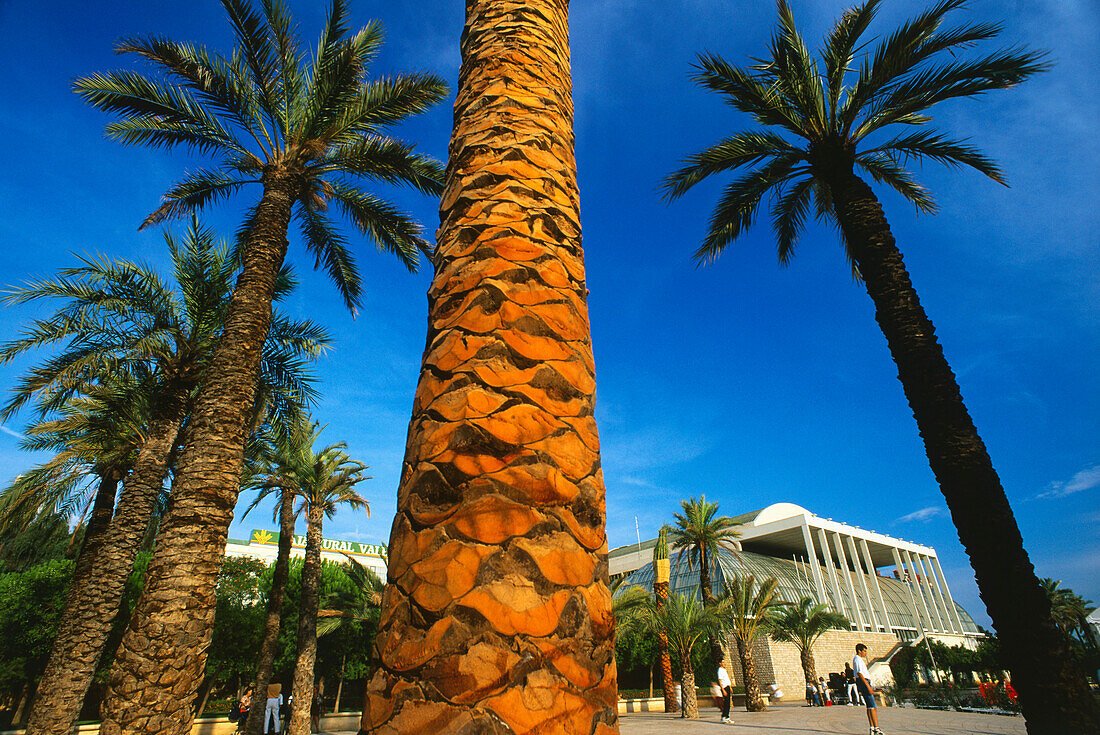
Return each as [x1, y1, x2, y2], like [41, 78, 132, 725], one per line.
[26, 382, 190, 735]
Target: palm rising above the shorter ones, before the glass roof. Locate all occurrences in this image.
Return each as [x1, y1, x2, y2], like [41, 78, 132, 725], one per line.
[669, 495, 741, 670]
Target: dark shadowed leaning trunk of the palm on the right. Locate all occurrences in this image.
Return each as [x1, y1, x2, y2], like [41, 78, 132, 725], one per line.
[829, 171, 1100, 735]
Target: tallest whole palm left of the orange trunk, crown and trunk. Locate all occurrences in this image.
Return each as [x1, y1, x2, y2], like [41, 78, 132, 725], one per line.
[75, 0, 446, 733]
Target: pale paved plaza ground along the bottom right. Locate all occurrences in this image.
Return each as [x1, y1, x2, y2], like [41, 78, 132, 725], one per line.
[619, 704, 1026, 735]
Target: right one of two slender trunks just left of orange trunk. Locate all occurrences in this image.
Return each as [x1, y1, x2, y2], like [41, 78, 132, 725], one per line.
[287, 503, 325, 735]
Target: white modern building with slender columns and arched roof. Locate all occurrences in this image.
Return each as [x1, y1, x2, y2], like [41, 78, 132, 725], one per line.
[608, 503, 981, 696]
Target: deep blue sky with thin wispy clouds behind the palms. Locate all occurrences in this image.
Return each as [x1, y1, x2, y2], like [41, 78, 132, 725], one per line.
[0, 0, 1100, 624]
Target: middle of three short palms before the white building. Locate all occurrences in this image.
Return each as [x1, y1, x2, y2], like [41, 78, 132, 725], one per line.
[715, 574, 777, 712]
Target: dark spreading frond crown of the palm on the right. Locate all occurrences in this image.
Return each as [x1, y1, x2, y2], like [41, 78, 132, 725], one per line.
[663, 0, 1045, 264]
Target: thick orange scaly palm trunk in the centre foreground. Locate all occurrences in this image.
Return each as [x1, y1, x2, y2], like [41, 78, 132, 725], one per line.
[362, 0, 617, 735]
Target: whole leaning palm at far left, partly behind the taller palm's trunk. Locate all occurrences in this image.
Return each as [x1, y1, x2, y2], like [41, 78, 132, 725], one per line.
[0, 219, 330, 734]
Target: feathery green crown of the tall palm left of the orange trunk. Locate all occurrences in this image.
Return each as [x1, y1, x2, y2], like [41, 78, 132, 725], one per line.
[74, 0, 447, 310]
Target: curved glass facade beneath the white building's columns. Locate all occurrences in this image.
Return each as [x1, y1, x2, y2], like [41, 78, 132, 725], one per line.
[616, 549, 979, 639]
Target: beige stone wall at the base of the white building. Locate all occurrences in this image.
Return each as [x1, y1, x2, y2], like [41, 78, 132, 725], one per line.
[729, 630, 898, 700]
